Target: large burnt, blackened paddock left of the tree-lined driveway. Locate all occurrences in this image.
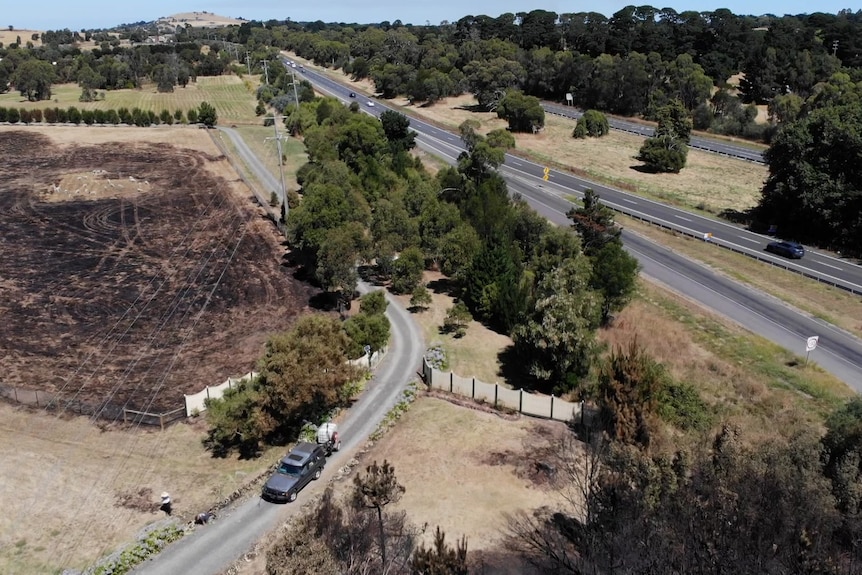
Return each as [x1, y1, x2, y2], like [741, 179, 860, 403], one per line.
[0, 128, 313, 418]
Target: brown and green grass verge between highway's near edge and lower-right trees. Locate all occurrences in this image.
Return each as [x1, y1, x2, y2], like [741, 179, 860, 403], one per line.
[600, 281, 853, 444]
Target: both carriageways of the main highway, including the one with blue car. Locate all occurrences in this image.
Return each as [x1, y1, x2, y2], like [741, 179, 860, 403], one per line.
[294, 58, 862, 391]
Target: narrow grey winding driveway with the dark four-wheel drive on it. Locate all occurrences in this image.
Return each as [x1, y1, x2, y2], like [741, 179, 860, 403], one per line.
[133, 129, 425, 575]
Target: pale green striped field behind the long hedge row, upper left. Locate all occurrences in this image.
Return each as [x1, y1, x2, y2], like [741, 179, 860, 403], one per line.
[0, 75, 261, 125]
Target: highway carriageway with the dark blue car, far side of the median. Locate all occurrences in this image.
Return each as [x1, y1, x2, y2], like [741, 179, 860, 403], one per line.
[292, 60, 862, 295]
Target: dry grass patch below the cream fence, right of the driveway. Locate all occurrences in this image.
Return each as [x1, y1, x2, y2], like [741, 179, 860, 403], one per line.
[354, 397, 564, 550]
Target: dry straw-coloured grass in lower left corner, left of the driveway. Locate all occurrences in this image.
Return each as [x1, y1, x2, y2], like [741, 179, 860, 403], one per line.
[0, 403, 281, 573]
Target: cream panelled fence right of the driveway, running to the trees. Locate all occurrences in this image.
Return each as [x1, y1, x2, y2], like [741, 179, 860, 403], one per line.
[422, 359, 593, 424]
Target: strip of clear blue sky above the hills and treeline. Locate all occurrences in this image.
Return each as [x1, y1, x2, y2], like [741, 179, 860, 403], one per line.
[0, 0, 860, 30]
